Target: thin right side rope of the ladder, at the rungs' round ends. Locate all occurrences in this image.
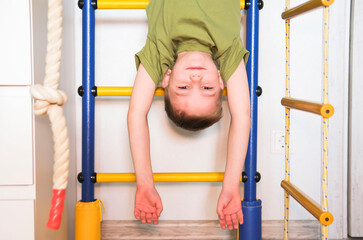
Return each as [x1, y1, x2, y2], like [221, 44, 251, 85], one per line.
[321, 7, 329, 240]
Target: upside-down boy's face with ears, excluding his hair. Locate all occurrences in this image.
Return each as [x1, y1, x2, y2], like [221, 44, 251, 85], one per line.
[163, 52, 224, 116]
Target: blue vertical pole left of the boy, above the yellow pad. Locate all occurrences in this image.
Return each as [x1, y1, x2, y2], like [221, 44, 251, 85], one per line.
[81, 0, 95, 202]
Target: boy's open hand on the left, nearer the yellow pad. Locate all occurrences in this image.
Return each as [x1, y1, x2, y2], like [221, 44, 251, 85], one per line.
[134, 186, 163, 224]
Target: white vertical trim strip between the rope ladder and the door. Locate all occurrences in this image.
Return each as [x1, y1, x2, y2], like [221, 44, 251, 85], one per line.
[328, 1, 351, 239]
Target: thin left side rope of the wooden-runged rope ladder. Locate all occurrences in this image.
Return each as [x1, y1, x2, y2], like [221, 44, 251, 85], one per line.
[284, 0, 291, 240]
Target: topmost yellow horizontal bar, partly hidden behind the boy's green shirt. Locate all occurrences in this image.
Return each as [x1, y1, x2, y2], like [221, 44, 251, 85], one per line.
[97, 0, 245, 9]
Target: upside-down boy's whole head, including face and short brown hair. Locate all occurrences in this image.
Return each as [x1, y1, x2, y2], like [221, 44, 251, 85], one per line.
[163, 52, 224, 131]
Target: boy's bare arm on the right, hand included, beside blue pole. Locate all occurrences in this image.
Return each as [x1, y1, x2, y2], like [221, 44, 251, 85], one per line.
[217, 60, 251, 229]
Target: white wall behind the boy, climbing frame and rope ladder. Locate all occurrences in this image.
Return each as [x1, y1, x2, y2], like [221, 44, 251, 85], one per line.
[75, 0, 349, 238]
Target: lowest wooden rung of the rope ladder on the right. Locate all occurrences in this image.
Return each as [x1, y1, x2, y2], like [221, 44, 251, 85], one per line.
[281, 180, 334, 226]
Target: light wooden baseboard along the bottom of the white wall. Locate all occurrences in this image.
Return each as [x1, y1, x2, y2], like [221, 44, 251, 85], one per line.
[101, 220, 320, 240]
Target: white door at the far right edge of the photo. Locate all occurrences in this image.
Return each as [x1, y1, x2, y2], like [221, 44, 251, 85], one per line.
[349, 0, 363, 237]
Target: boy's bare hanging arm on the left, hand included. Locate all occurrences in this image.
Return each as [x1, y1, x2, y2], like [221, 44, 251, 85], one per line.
[127, 64, 162, 224]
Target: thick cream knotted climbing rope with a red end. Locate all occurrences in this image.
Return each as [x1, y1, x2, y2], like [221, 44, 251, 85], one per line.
[31, 0, 69, 229]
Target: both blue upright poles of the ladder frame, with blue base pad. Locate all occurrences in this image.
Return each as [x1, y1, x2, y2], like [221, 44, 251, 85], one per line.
[81, 0, 263, 240]
